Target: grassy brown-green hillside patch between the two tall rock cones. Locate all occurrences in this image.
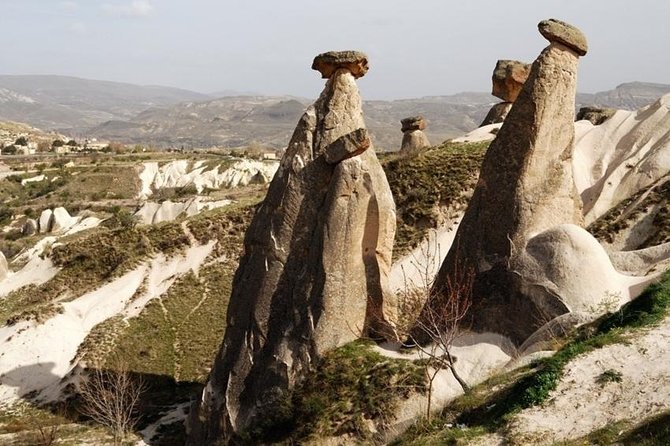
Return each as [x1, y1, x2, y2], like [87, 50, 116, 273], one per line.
[382, 142, 489, 257]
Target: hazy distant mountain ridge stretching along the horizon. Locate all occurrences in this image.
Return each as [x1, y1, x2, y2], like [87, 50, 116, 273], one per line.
[0, 76, 670, 150]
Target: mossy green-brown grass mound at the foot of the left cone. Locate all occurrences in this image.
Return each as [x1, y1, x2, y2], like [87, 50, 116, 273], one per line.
[243, 340, 427, 444]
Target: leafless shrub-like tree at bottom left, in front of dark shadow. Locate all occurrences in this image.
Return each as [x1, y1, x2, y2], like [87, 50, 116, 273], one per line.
[79, 363, 146, 446]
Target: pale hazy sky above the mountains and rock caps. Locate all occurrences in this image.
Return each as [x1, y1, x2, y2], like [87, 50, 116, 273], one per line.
[0, 0, 670, 99]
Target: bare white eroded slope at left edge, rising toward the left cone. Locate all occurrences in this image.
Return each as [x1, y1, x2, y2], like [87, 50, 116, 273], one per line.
[0, 242, 214, 404]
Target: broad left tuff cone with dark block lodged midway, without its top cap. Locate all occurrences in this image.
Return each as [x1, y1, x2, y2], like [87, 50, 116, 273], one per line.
[187, 53, 395, 446]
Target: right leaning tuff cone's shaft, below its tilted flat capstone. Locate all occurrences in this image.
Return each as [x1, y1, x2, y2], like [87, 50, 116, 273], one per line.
[414, 18, 586, 344]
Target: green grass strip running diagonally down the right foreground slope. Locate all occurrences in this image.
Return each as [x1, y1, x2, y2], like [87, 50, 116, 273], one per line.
[396, 272, 670, 445]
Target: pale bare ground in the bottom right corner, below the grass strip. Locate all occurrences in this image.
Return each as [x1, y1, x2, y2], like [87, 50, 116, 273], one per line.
[511, 312, 670, 444]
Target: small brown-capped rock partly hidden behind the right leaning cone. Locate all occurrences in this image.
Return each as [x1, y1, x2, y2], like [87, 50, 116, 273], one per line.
[480, 60, 530, 127]
